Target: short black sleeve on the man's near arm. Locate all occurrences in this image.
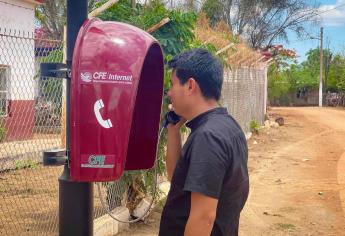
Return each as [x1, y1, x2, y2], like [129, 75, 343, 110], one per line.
[183, 132, 231, 199]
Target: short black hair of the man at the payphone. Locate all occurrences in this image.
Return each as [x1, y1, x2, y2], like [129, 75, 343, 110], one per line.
[168, 48, 223, 101]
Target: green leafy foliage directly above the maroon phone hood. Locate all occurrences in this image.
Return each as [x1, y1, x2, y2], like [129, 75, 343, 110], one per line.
[99, 0, 196, 55]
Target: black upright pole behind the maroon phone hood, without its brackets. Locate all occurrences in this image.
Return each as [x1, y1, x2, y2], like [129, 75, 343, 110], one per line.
[59, 0, 93, 236]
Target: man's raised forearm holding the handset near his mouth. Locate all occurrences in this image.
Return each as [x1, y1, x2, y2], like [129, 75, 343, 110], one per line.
[165, 118, 186, 181]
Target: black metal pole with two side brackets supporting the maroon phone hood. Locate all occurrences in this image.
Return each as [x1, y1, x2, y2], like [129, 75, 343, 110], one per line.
[41, 0, 93, 236]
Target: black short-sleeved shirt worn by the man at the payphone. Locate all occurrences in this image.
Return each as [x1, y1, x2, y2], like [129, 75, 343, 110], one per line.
[159, 108, 249, 236]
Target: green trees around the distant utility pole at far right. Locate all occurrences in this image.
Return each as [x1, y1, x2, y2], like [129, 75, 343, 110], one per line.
[268, 48, 345, 102]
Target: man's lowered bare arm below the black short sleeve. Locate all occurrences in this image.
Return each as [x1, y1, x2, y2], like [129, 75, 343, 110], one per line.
[184, 192, 218, 236]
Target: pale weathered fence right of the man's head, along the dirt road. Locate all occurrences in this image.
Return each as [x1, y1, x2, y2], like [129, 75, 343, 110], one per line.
[221, 67, 267, 132]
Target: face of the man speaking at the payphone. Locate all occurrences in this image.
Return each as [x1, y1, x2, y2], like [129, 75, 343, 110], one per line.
[168, 70, 188, 116]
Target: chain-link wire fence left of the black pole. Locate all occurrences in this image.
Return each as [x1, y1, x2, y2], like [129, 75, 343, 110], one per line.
[0, 29, 63, 235]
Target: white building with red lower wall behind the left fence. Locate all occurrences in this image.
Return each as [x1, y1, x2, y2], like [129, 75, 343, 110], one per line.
[0, 0, 43, 140]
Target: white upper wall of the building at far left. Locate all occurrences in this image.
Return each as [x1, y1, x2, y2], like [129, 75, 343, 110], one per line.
[0, 0, 35, 100]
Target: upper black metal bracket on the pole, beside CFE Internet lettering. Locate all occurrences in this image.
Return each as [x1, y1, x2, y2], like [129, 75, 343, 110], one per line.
[40, 63, 71, 79]
